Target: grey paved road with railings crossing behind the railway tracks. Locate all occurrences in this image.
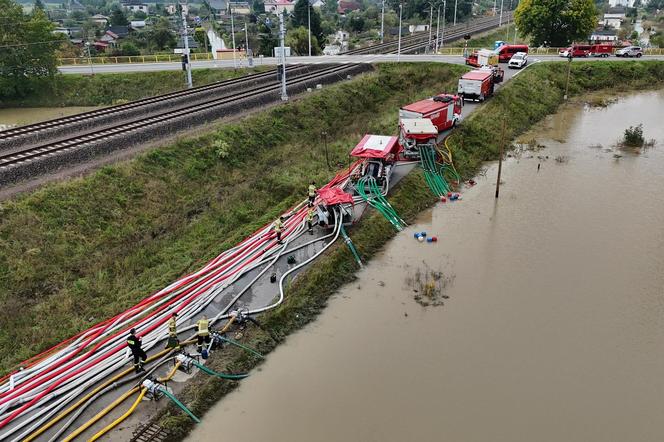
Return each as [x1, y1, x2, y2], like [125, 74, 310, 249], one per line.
[59, 54, 664, 74]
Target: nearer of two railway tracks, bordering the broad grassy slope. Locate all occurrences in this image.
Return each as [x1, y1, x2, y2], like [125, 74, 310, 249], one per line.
[0, 64, 371, 184]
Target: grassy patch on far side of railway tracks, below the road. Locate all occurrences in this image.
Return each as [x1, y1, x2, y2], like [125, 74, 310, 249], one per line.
[0, 66, 274, 108]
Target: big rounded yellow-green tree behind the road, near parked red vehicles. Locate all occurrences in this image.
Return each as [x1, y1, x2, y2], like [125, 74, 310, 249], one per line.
[514, 0, 597, 47]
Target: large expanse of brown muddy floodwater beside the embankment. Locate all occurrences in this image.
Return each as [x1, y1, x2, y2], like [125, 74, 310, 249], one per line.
[189, 92, 664, 442]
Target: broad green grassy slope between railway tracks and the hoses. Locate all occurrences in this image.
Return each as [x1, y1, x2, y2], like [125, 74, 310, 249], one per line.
[0, 64, 465, 371]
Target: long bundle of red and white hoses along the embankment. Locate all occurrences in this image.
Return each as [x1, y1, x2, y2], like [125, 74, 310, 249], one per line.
[0, 165, 356, 441]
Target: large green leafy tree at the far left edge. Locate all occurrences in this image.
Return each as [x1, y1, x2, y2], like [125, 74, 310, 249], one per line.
[0, 0, 64, 100]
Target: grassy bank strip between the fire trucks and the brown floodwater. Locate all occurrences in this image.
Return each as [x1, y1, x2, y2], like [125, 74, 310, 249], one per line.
[153, 62, 664, 440]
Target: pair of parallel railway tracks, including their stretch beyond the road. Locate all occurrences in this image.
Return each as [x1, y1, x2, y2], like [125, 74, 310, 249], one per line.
[0, 13, 511, 184]
